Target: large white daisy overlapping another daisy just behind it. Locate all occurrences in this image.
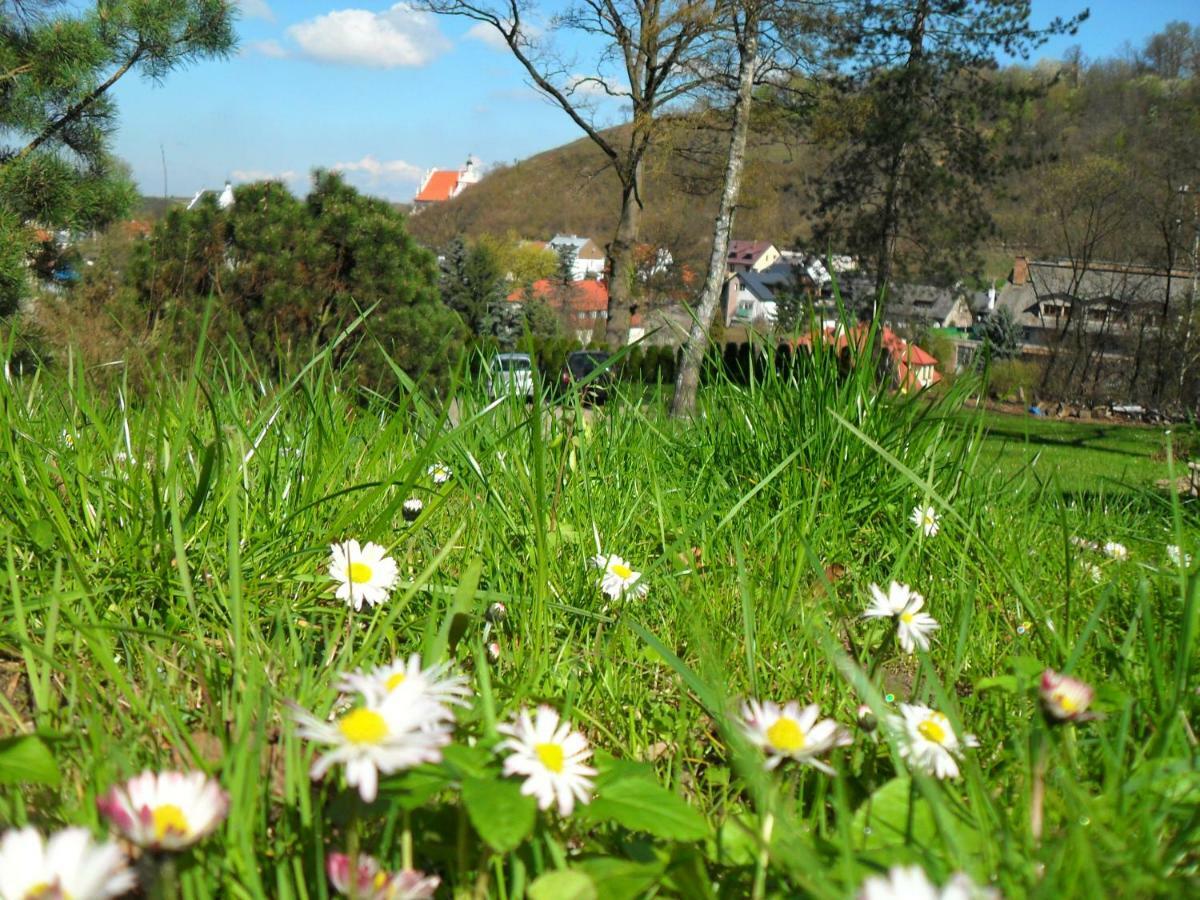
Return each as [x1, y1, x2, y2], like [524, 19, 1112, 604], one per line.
[293, 694, 450, 803]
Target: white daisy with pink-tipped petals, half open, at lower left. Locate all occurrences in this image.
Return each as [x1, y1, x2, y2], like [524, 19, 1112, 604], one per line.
[96, 770, 229, 850]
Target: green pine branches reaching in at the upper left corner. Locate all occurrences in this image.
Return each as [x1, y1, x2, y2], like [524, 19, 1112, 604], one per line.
[0, 0, 235, 314]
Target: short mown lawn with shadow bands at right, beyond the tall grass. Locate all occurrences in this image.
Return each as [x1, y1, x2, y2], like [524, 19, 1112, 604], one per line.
[982, 412, 1198, 493]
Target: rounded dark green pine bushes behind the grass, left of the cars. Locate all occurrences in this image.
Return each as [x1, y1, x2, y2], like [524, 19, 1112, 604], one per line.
[128, 172, 463, 386]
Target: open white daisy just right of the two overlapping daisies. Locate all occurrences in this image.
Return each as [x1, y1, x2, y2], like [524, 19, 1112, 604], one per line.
[497, 706, 596, 816]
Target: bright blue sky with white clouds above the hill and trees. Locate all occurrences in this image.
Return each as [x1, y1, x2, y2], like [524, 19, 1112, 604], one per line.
[114, 0, 1200, 200]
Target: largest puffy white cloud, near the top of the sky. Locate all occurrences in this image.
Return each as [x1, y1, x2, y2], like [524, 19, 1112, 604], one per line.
[287, 4, 450, 68]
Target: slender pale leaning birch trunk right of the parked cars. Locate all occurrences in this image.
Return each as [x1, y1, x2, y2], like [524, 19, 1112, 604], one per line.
[671, 10, 758, 416]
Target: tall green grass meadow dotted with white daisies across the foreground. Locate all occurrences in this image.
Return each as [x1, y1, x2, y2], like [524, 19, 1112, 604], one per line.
[0, 336, 1200, 900]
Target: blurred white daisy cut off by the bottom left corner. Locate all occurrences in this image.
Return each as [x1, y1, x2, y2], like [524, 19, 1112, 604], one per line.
[0, 828, 137, 900]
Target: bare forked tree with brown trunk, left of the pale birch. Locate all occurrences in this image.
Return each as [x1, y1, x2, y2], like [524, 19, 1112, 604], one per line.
[415, 0, 719, 349]
